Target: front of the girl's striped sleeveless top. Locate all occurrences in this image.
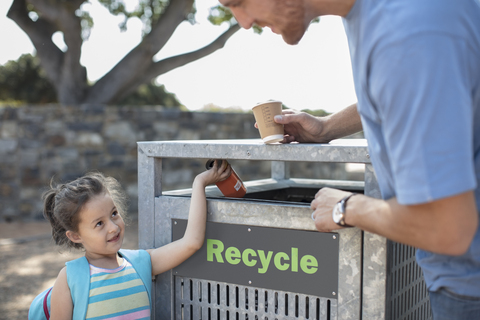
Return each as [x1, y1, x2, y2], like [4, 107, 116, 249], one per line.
[86, 259, 150, 320]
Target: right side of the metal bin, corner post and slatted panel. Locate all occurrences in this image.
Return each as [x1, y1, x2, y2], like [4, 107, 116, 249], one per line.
[362, 164, 432, 320]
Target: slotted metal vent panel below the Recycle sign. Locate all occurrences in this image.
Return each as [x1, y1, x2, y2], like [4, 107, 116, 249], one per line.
[174, 276, 337, 320]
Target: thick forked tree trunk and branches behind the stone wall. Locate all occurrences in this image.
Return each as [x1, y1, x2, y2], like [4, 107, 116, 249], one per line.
[7, 0, 239, 105]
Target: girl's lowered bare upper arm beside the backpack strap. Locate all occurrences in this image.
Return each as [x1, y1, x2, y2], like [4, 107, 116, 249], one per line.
[50, 267, 73, 320]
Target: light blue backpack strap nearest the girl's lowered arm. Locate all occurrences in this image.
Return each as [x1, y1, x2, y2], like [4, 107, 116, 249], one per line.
[65, 257, 90, 319]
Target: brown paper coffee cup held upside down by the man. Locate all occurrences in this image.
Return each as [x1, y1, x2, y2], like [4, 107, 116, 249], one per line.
[252, 100, 283, 143]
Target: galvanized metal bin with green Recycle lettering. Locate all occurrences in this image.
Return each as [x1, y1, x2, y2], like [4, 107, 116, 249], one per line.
[138, 139, 431, 320]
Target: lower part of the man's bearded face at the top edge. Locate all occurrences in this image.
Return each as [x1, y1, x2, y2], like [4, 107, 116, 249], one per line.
[219, 0, 311, 44]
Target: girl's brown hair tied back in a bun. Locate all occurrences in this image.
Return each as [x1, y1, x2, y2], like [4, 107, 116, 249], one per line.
[43, 172, 126, 249]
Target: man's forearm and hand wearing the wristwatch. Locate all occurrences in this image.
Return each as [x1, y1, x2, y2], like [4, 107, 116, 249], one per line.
[311, 188, 478, 255]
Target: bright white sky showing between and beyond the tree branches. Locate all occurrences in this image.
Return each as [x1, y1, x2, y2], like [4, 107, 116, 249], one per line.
[0, 0, 356, 112]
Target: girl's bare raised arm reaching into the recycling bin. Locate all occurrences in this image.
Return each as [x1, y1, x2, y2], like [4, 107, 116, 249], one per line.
[147, 161, 231, 275]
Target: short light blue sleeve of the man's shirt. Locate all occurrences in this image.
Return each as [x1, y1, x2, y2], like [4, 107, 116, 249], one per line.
[368, 33, 476, 204]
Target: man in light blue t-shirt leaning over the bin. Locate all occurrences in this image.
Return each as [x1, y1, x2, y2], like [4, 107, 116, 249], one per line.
[220, 0, 480, 319]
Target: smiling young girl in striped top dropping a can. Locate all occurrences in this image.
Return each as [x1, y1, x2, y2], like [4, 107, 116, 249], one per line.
[39, 161, 231, 320]
